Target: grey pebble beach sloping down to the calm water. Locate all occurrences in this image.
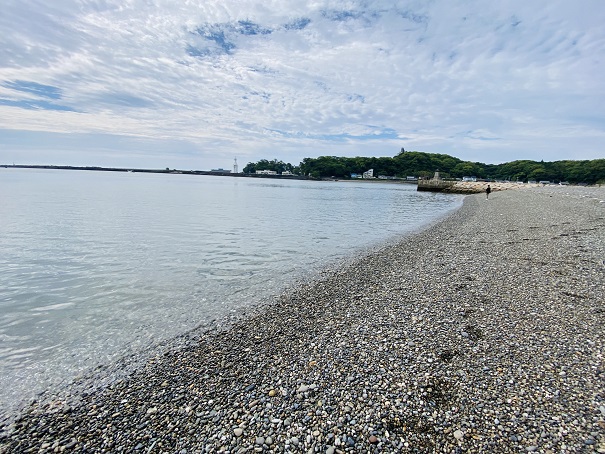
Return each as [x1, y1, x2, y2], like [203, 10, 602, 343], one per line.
[0, 186, 605, 453]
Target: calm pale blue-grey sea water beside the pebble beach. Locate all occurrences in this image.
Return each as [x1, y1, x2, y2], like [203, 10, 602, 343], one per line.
[0, 169, 461, 411]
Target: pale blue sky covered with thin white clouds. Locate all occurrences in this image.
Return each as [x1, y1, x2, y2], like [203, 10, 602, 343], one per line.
[0, 0, 605, 170]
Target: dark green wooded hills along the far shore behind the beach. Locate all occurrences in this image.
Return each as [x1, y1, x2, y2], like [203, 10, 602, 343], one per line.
[244, 151, 605, 184]
